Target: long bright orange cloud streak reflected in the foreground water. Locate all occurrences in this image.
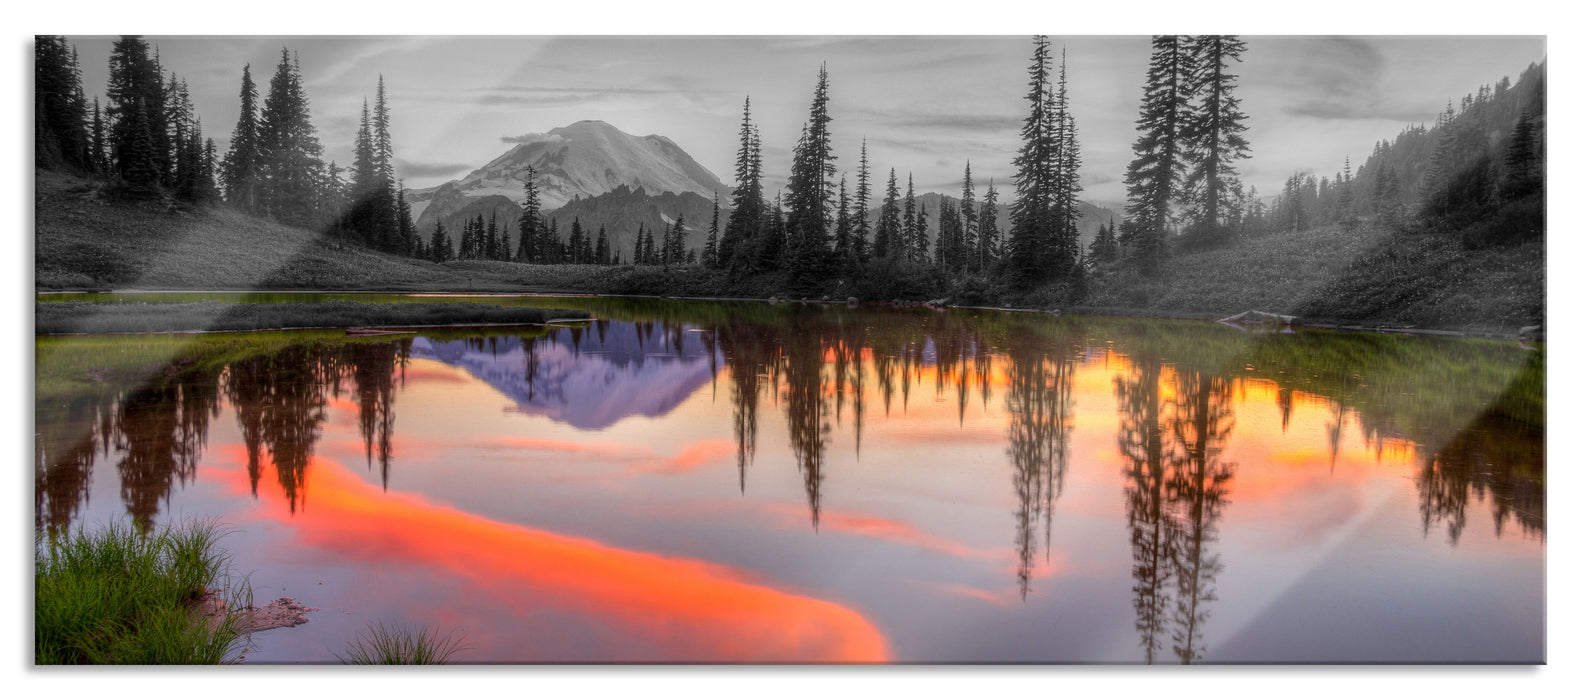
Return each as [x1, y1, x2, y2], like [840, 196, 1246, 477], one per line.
[225, 450, 891, 664]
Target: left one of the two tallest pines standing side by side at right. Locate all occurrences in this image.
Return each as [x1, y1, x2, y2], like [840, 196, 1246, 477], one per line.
[1120, 35, 1194, 271]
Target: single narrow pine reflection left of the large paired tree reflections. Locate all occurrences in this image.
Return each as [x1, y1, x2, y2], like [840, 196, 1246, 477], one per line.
[1006, 335, 1073, 599]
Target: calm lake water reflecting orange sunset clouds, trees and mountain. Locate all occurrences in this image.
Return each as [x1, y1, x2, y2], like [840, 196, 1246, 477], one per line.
[35, 295, 1546, 664]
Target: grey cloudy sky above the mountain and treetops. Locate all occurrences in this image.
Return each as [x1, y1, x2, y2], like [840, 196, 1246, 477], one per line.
[71, 35, 1546, 203]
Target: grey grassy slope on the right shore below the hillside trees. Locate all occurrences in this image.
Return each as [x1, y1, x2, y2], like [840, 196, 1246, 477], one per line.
[1084, 225, 1544, 329]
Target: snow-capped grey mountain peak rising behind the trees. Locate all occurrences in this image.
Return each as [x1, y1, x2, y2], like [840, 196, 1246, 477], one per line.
[407, 120, 729, 233]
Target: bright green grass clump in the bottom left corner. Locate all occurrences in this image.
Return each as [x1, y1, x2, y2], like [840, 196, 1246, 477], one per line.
[33, 521, 242, 665]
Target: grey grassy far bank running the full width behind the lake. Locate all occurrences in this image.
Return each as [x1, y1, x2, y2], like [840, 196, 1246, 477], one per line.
[35, 173, 1544, 329]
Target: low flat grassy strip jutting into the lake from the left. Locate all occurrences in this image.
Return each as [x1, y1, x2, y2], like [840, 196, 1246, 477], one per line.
[33, 301, 589, 334]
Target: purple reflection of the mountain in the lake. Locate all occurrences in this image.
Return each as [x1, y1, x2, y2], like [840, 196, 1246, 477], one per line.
[413, 321, 718, 431]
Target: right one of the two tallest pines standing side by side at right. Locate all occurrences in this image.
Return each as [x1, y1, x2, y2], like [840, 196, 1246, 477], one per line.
[1182, 35, 1248, 242]
